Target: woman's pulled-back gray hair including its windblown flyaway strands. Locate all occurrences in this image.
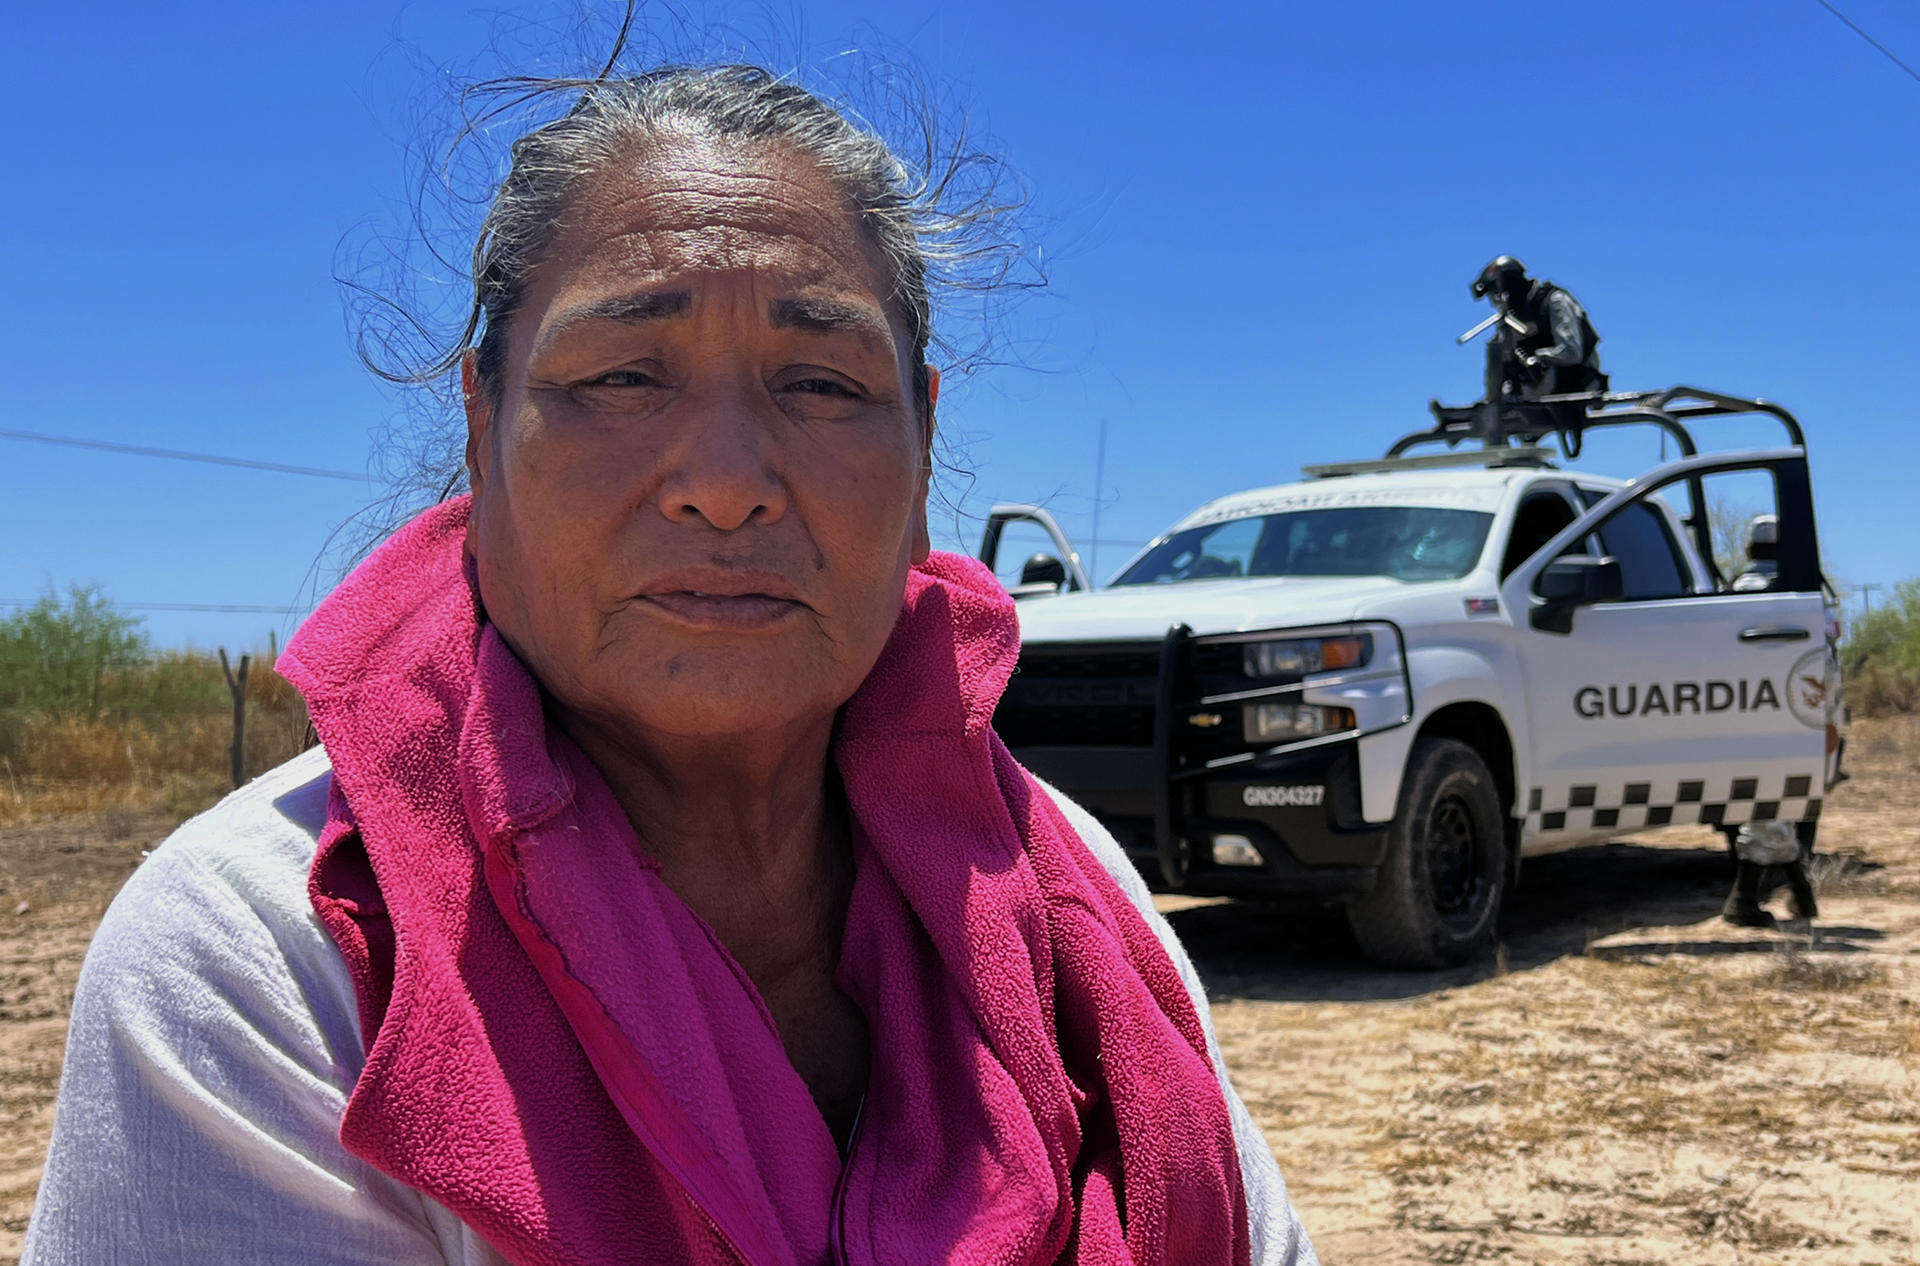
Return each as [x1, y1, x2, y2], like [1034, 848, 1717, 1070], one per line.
[337, 17, 1046, 574]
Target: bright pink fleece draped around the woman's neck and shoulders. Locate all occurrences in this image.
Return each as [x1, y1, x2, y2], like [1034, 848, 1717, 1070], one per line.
[280, 499, 1248, 1266]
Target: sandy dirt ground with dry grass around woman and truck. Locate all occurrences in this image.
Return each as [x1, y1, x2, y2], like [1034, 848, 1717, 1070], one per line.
[0, 718, 1920, 1266]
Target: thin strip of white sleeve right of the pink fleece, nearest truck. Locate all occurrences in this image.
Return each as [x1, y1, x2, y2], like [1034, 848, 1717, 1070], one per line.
[1035, 778, 1319, 1266]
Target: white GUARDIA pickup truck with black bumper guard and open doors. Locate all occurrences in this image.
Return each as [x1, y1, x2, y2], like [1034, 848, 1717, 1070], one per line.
[981, 388, 1839, 966]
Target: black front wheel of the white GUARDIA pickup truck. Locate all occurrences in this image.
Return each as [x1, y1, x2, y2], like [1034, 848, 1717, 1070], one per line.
[1346, 738, 1507, 968]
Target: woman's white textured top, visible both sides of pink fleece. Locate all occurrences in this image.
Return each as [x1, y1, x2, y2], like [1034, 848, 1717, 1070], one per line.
[21, 749, 1317, 1266]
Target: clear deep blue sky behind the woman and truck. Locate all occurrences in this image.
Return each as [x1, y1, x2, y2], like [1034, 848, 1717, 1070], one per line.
[0, 0, 1920, 645]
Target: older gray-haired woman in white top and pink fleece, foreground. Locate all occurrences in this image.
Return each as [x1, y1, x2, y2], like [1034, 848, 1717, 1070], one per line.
[27, 67, 1313, 1266]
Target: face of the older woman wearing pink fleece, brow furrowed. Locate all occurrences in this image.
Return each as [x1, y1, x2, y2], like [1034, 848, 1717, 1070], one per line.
[467, 136, 929, 738]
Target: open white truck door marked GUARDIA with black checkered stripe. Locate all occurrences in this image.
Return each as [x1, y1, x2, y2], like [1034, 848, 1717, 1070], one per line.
[1501, 448, 1839, 851]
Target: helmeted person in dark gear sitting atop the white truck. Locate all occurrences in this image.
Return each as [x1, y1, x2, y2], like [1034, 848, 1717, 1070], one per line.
[1473, 256, 1607, 409]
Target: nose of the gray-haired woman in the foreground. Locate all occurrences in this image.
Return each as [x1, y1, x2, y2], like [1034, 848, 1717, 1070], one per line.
[660, 384, 787, 532]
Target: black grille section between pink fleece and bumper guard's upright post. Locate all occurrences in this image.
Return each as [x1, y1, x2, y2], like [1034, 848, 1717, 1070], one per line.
[993, 642, 1160, 747]
